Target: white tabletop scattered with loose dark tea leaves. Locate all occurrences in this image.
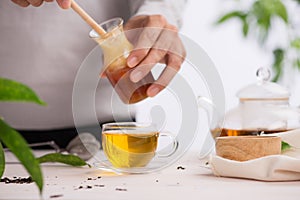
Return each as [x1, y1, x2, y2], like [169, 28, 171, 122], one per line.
[0, 151, 300, 200]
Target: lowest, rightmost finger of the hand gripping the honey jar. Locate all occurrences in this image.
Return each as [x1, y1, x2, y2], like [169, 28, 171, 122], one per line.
[147, 54, 183, 97]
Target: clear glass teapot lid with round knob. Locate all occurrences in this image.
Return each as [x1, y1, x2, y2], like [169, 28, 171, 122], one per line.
[237, 68, 290, 100]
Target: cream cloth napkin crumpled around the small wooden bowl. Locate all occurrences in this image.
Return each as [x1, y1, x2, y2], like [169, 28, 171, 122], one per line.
[209, 129, 300, 181]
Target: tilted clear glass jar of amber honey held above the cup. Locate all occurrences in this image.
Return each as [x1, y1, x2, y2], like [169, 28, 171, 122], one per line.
[90, 18, 154, 104]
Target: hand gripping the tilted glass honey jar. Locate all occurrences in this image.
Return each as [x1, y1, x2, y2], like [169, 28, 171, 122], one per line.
[124, 15, 186, 97]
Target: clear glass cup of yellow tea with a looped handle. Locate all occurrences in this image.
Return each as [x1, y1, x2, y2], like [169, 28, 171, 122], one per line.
[102, 122, 178, 168]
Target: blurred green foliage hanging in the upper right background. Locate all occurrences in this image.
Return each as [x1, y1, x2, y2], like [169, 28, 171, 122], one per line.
[217, 0, 300, 82]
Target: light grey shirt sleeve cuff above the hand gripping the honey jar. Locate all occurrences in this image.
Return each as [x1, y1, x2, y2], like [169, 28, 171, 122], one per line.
[129, 0, 187, 28]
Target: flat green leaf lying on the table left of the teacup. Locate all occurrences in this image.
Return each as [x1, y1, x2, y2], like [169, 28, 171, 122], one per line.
[37, 153, 90, 167]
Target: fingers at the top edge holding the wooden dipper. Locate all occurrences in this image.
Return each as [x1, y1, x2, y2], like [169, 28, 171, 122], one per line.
[11, 0, 71, 9]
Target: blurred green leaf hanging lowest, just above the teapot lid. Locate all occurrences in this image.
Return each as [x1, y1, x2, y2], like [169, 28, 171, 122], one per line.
[272, 48, 285, 82]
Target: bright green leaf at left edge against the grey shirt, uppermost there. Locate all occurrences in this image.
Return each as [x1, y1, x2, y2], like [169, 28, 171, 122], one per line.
[0, 78, 46, 105]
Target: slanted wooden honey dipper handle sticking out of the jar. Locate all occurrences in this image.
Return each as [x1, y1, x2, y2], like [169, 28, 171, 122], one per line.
[71, 0, 106, 37]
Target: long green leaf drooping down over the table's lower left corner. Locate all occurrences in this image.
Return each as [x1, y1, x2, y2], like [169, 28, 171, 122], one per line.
[0, 119, 43, 193]
